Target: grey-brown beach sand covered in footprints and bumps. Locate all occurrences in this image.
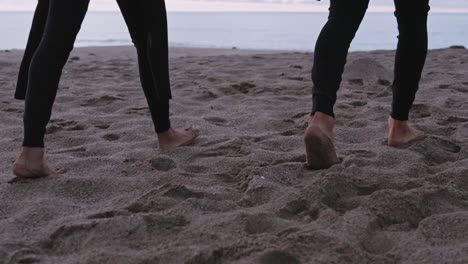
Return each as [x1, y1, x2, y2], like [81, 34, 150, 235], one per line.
[0, 47, 468, 264]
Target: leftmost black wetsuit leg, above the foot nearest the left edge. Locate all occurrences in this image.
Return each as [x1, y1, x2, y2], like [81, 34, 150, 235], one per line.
[23, 0, 89, 147]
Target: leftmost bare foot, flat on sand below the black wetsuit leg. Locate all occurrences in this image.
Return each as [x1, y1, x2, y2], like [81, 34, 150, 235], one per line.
[13, 147, 64, 178]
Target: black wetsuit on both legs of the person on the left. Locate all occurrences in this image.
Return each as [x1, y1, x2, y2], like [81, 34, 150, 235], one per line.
[15, 0, 171, 147]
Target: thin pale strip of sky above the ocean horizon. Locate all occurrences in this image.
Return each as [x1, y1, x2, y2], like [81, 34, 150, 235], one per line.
[0, 0, 468, 14]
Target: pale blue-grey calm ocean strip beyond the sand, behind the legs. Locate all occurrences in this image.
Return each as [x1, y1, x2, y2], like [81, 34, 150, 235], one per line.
[0, 12, 468, 51]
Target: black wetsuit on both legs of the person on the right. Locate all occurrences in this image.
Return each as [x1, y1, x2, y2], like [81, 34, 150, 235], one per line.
[312, 0, 430, 121]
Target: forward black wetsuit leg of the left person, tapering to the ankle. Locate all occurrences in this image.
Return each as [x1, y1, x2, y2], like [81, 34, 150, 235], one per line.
[117, 0, 172, 133]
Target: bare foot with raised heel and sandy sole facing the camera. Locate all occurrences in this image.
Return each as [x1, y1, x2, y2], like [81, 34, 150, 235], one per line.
[304, 112, 340, 170]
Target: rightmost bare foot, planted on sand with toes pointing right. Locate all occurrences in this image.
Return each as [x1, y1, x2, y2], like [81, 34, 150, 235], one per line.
[387, 117, 425, 148]
